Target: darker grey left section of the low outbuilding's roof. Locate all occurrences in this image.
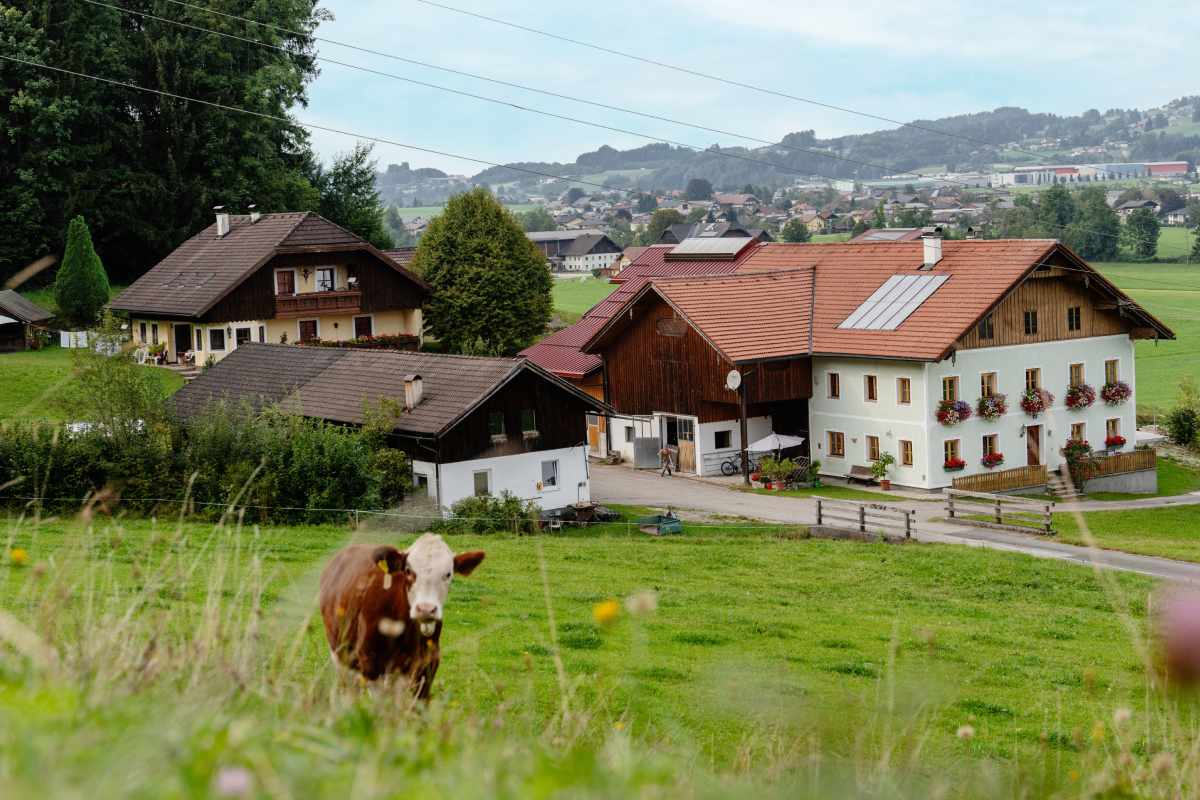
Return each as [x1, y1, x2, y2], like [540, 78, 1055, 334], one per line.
[170, 342, 349, 421]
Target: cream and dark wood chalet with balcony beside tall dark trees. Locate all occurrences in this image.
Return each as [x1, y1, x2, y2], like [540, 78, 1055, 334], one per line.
[108, 211, 431, 363]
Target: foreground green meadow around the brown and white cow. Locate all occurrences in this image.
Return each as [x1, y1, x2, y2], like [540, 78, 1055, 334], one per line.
[0, 509, 1195, 799]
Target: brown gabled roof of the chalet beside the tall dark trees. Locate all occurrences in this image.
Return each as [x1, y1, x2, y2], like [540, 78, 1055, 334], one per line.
[108, 211, 428, 317]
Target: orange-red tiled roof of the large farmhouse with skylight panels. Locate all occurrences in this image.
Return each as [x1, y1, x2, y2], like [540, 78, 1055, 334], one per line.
[583, 239, 1174, 362]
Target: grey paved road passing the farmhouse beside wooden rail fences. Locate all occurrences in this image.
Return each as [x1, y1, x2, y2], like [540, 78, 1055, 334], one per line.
[592, 464, 1200, 583]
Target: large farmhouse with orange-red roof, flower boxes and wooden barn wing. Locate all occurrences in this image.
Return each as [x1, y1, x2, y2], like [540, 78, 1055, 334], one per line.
[578, 234, 1175, 492]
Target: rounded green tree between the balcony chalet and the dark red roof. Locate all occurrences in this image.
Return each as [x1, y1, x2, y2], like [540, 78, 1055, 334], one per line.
[412, 186, 554, 354]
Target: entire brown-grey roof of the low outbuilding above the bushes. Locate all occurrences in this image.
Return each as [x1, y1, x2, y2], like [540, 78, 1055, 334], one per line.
[175, 342, 611, 435]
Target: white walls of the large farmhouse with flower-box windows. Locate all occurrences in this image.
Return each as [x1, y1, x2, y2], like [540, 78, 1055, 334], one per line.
[809, 335, 1136, 489]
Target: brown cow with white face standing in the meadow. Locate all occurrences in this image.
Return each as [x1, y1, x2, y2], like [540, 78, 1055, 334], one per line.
[319, 534, 487, 698]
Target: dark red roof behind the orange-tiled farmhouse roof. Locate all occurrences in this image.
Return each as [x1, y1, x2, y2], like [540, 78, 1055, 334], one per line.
[521, 240, 762, 378]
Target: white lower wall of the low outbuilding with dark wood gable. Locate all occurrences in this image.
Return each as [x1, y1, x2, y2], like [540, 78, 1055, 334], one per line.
[413, 446, 592, 509]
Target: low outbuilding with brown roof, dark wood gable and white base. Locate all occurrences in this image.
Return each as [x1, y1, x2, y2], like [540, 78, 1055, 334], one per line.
[172, 342, 612, 510]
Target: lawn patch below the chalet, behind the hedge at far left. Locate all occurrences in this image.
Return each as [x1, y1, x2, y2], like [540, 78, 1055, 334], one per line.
[0, 344, 184, 422]
